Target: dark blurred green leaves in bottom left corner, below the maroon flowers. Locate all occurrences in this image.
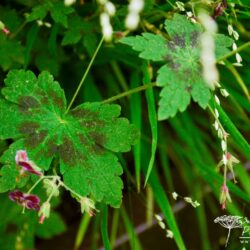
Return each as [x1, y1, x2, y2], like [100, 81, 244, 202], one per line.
[0, 195, 66, 250]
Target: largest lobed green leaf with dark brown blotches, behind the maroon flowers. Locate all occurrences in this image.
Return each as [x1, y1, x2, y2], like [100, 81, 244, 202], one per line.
[0, 70, 138, 207]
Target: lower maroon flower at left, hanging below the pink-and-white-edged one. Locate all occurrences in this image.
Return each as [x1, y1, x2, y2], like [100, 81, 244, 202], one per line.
[9, 190, 40, 211]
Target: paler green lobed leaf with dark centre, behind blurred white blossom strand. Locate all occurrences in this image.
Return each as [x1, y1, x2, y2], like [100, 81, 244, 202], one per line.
[121, 14, 232, 120]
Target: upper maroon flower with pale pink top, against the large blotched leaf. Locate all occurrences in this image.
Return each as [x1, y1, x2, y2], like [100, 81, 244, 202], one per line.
[15, 150, 42, 176]
